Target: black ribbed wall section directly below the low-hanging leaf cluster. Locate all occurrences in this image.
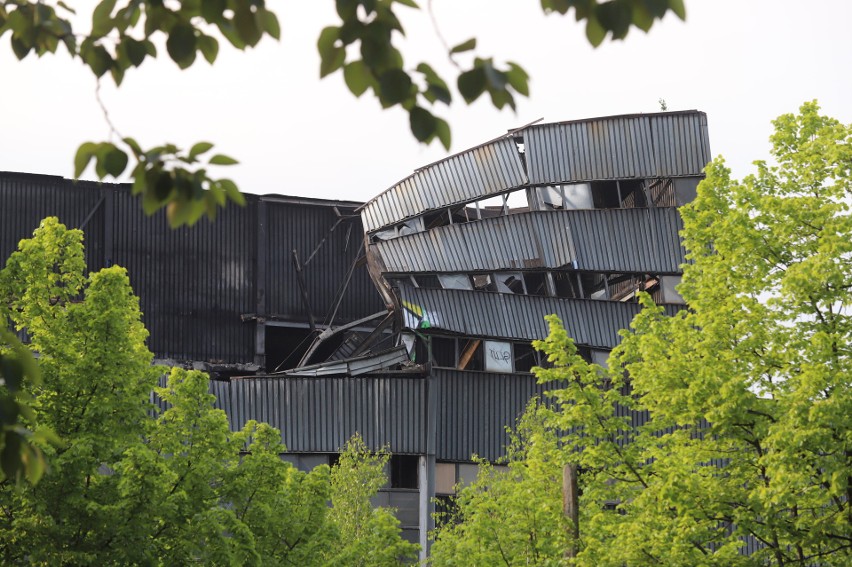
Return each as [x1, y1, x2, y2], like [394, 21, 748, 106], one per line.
[112, 191, 257, 362]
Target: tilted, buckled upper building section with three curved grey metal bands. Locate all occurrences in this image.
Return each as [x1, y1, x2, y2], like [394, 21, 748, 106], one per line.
[350, 111, 710, 372]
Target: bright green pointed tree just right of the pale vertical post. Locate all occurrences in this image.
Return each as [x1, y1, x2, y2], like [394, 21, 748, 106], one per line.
[431, 399, 571, 566]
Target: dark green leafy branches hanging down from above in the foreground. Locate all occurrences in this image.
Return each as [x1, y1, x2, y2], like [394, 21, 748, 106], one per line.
[0, 0, 685, 226]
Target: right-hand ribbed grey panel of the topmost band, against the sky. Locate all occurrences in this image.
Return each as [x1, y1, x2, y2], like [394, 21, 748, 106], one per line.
[523, 111, 710, 185]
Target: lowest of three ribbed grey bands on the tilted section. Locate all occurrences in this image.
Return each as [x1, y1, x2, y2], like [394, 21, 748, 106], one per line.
[400, 288, 678, 349]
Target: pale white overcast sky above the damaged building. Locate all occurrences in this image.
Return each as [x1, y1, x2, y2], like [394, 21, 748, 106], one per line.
[0, 0, 852, 200]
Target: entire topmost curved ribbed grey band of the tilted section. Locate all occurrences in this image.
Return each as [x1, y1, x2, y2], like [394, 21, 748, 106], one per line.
[361, 111, 710, 232]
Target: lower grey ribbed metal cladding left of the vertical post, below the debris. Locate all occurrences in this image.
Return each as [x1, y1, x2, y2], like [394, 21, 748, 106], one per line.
[219, 377, 426, 454]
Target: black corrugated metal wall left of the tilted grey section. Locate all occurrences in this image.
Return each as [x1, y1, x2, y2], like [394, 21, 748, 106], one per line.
[0, 173, 384, 363]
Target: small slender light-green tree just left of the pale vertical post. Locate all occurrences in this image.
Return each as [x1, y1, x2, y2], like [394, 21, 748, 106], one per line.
[325, 433, 420, 567]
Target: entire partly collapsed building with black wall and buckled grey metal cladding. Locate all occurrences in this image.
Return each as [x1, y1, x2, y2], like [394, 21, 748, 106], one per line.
[0, 111, 710, 560]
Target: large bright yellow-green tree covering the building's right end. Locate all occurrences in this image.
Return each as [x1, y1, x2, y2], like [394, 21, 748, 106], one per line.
[432, 102, 852, 566]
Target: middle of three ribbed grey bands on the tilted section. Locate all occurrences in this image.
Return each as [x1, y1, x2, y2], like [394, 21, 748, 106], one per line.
[371, 208, 685, 273]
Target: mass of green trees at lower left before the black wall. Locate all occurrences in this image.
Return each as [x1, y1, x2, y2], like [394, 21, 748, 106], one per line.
[0, 218, 416, 565]
